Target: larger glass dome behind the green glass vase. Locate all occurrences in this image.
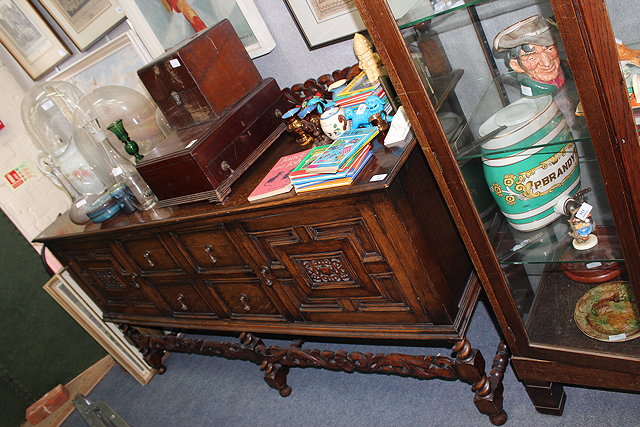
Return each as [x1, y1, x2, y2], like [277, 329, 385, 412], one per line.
[74, 86, 167, 162]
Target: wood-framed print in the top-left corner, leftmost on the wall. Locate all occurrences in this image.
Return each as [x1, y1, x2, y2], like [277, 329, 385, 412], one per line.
[0, 0, 70, 80]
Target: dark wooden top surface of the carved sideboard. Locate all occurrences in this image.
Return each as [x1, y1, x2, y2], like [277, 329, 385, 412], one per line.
[34, 133, 416, 243]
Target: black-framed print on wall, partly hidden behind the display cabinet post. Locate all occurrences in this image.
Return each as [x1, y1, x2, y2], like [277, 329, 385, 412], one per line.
[285, 0, 421, 49]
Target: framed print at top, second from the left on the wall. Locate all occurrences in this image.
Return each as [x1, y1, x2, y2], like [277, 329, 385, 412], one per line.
[40, 0, 125, 50]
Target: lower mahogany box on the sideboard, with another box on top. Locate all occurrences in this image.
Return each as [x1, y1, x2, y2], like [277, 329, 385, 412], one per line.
[136, 78, 285, 207]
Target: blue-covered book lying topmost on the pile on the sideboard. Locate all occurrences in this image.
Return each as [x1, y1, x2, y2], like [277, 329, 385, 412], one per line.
[306, 127, 378, 173]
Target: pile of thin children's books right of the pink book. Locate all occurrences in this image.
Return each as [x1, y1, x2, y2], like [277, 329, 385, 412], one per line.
[289, 127, 378, 193]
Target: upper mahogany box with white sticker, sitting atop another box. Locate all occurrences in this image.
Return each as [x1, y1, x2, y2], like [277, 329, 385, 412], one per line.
[138, 19, 262, 129]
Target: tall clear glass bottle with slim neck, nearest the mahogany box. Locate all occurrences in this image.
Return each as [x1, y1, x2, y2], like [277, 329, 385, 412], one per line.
[82, 120, 158, 210]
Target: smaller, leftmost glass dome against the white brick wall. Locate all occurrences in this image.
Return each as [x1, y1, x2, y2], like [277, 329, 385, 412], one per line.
[21, 81, 82, 157]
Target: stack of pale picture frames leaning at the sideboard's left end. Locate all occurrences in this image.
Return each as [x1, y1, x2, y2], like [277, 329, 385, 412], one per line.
[43, 269, 156, 385]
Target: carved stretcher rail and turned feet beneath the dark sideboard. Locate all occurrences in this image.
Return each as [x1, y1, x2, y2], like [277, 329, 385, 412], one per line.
[120, 325, 509, 425]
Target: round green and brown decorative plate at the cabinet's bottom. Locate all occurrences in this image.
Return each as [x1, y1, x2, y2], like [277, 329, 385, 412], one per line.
[573, 281, 640, 342]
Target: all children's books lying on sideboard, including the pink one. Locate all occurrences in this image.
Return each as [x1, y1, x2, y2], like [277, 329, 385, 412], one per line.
[247, 127, 378, 202]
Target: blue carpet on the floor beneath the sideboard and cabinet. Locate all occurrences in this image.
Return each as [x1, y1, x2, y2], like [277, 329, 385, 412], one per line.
[63, 304, 640, 427]
